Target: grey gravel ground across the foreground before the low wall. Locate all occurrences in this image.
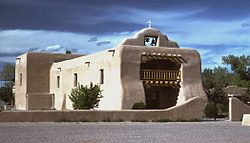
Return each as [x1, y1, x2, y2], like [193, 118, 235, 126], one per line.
[0, 121, 250, 143]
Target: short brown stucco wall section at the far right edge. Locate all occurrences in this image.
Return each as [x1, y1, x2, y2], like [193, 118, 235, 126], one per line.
[229, 97, 250, 121]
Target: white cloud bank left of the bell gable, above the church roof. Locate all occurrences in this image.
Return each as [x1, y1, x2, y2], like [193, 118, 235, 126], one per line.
[0, 29, 135, 62]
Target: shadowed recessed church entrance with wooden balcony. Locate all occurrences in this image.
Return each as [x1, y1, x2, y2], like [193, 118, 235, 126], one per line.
[141, 55, 184, 109]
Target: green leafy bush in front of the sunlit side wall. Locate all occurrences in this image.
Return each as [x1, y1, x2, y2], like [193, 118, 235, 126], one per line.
[69, 82, 103, 109]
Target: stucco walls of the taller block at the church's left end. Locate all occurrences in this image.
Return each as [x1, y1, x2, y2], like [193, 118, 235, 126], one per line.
[15, 52, 81, 110]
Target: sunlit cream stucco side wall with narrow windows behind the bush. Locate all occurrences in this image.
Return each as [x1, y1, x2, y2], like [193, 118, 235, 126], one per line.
[50, 50, 122, 110]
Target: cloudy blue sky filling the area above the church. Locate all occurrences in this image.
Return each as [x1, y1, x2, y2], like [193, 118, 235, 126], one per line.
[0, 0, 250, 69]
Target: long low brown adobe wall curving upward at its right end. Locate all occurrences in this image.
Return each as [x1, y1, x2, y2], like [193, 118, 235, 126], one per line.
[0, 97, 205, 122]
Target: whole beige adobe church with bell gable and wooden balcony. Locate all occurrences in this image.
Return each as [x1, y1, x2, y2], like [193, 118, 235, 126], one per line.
[15, 27, 207, 111]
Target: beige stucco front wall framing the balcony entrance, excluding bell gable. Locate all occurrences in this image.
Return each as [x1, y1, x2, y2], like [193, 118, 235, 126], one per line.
[121, 46, 207, 109]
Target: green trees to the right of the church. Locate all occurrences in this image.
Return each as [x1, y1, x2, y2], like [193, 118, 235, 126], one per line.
[202, 55, 250, 116]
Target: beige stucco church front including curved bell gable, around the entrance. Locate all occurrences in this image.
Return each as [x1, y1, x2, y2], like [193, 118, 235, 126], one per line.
[116, 28, 207, 109]
